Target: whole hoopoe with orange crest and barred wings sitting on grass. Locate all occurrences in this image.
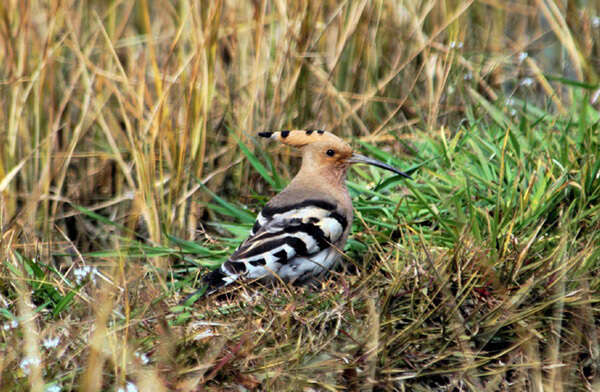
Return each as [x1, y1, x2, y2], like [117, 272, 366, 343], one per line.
[204, 130, 410, 294]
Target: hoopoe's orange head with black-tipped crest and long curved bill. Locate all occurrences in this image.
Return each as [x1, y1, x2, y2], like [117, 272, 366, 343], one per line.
[258, 130, 410, 179]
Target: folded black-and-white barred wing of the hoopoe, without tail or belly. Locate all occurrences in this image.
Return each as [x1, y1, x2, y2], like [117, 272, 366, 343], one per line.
[220, 200, 348, 284]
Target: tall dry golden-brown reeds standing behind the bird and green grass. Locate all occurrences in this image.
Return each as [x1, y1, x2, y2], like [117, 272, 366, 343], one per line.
[0, 0, 600, 250]
